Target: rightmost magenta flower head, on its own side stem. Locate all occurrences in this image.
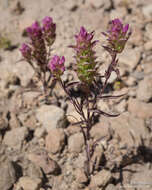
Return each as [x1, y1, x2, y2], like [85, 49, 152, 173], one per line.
[102, 18, 131, 53]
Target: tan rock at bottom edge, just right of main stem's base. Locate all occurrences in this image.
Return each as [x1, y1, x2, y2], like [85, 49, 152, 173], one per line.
[90, 169, 112, 188]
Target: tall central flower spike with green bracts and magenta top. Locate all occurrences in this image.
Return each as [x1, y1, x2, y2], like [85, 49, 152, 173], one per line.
[70, 27, 97, 84]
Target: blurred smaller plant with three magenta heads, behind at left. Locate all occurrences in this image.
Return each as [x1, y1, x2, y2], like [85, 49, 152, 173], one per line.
[20, 17, 56, 95]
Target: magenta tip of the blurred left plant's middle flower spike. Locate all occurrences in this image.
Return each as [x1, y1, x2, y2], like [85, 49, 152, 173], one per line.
[26, 21, 42, 40]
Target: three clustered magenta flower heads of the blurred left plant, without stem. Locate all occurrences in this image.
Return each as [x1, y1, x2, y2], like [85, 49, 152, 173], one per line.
[20, 17, 56, 71]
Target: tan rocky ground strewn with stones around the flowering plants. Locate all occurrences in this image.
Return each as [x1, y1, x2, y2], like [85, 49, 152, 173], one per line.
[0, 0, 152, 190]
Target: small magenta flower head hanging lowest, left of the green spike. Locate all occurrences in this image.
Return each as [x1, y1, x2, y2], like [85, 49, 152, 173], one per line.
[48, 55, 65, 76]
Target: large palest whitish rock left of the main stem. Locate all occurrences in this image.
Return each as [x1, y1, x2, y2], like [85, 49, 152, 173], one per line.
[36, 105, 67, 132]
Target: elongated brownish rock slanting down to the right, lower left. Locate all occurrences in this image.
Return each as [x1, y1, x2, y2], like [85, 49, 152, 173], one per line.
[27, 153, 60, 175]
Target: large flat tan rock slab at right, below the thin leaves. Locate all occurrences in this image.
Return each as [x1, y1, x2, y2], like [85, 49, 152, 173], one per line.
[110, 112, 149, 147]
